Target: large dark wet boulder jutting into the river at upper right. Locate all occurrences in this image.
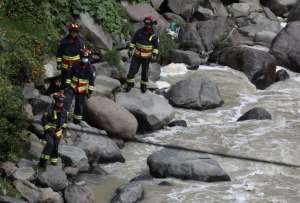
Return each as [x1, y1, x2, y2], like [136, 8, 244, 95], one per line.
[218, 46, 276, 89]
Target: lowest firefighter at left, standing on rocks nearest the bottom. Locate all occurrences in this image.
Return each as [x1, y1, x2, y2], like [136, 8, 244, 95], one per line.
[39, 93, 67, 168]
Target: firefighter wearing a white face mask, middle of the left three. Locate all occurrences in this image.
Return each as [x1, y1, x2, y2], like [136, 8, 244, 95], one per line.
[65, 48, 95, 124]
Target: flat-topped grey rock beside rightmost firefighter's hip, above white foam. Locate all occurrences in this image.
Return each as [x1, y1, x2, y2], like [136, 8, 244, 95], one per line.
[169, 49, 206, 66]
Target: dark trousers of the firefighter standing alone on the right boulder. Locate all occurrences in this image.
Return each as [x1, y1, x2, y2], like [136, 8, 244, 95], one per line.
[127, 55, 150, 87]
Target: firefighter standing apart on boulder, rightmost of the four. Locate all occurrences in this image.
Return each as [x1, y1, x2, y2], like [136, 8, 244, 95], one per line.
[126, 16, 159, 93]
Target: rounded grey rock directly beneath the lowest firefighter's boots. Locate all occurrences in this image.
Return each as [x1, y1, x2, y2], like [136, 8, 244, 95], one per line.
[37, 165, 68, 191]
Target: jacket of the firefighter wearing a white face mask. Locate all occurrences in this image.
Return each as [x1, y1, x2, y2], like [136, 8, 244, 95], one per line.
[66, 63, 96, 94]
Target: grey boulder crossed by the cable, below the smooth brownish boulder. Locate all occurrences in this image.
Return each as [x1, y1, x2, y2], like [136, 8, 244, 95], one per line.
[67, 124, 125, 163]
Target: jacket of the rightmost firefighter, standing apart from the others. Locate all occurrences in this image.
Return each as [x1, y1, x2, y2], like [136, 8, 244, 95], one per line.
[129, 28, 159, 58]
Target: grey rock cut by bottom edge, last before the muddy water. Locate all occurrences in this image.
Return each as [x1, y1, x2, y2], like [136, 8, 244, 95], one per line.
[64, 185, 95, 203]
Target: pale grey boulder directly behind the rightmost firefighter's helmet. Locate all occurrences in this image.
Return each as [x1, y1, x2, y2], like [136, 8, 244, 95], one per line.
[126, 3, 169, 31]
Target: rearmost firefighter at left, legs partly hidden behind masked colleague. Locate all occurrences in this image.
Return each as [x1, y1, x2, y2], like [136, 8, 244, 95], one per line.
[56, 23, 85, 90]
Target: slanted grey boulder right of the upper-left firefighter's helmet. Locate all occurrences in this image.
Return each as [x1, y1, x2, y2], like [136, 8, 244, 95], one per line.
[79, 13, 112, 49]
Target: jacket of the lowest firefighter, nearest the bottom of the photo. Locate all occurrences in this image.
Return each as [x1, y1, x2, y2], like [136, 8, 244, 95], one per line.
[42, 104, 67, 137]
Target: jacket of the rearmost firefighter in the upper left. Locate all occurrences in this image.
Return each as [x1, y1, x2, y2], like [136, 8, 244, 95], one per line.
[56, 35, 85, 69]
